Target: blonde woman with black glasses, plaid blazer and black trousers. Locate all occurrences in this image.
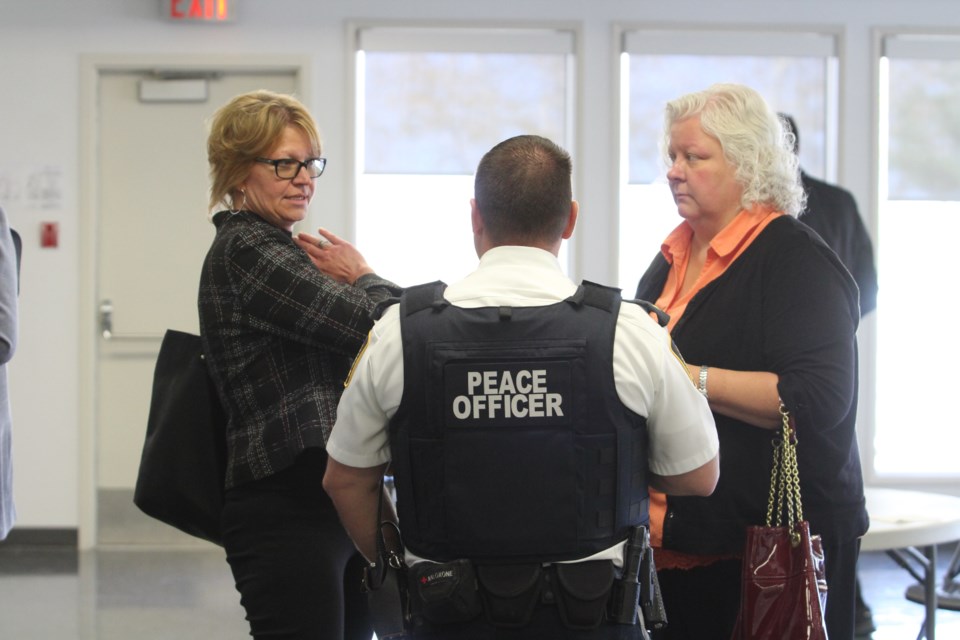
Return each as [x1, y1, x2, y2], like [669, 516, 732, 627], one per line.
[199, 91, 396, 640]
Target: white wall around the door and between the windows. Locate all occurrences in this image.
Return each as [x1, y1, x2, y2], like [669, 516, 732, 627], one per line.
[0, 0, 960, 527]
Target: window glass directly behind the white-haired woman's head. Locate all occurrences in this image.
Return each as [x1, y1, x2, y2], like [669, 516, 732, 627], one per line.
[618, 55, 831, 293]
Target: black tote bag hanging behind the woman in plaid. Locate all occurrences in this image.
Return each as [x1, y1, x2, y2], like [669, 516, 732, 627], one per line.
[133, 329, 227, 545]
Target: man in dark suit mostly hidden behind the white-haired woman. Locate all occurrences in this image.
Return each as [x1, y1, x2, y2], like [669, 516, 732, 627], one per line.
[780, 113, 877, 638]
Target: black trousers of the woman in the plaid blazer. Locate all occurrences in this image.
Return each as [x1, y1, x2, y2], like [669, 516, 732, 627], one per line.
[222, 449, 373, 640]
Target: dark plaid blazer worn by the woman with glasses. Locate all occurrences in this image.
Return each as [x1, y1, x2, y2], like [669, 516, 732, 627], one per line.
[198, 211, 400, 488]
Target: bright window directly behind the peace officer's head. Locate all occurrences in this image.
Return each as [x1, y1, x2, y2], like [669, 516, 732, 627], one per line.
[356, 27, 574, 285]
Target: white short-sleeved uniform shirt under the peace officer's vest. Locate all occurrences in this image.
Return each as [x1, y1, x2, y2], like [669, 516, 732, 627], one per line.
[327, 246, 719, 564]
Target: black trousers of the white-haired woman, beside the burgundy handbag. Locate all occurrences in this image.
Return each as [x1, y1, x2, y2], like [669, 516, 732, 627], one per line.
[654, 539, 860, 640]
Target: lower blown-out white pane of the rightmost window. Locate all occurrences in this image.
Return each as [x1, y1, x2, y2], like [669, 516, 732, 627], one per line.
[874, 201, 960, 477]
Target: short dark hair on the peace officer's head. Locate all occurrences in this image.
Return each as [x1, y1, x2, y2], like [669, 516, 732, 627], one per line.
[474, 135, 573, 245]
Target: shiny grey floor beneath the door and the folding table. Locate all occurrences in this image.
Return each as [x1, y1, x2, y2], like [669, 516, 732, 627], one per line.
[0, 545, 960, 640]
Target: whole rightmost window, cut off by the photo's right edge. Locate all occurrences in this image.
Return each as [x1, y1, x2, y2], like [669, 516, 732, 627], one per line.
[873, 35, 960, 478]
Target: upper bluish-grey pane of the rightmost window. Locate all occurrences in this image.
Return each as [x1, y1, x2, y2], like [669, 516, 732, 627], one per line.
[888, 58, 960, 200]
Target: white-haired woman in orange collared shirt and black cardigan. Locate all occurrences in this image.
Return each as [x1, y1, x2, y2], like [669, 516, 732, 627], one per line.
[637, 84, 867, 640]
